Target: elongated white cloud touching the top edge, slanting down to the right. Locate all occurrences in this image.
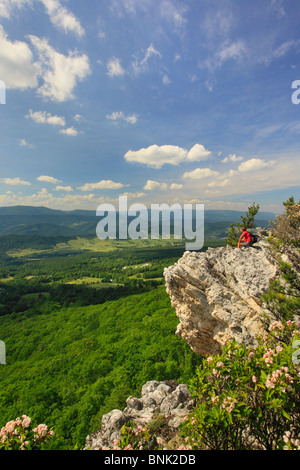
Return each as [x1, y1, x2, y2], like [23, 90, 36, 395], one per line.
[40, 0, 85, 37]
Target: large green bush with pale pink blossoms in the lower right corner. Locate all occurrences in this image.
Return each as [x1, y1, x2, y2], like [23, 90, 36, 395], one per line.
[183, 321, 300, 450]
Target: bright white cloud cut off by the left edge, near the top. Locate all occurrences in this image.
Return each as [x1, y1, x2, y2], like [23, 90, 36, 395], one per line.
[0, 25, 41, 90]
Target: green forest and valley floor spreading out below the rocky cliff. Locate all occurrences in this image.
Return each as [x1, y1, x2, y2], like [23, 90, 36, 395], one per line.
[0, 236, 218, 449]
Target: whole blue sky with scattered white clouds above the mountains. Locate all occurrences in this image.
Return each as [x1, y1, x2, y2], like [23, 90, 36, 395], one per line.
[0, 0, 300, 213]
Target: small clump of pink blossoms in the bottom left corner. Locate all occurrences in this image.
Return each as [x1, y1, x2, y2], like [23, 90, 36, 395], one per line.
[0, 415, 54, 450]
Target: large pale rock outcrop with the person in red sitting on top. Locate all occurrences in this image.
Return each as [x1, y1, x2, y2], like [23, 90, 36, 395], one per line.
[164, 231, 278, 355]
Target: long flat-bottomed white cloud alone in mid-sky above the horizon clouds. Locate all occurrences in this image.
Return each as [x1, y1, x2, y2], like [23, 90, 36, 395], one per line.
[124, 144, 211, 168]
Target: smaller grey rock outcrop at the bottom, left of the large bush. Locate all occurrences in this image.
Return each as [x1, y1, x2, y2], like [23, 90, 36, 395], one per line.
[85, 380, 194, 450]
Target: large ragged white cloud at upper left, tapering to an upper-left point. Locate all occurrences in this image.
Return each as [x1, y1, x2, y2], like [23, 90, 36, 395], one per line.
[29, 35, 90, 102]
